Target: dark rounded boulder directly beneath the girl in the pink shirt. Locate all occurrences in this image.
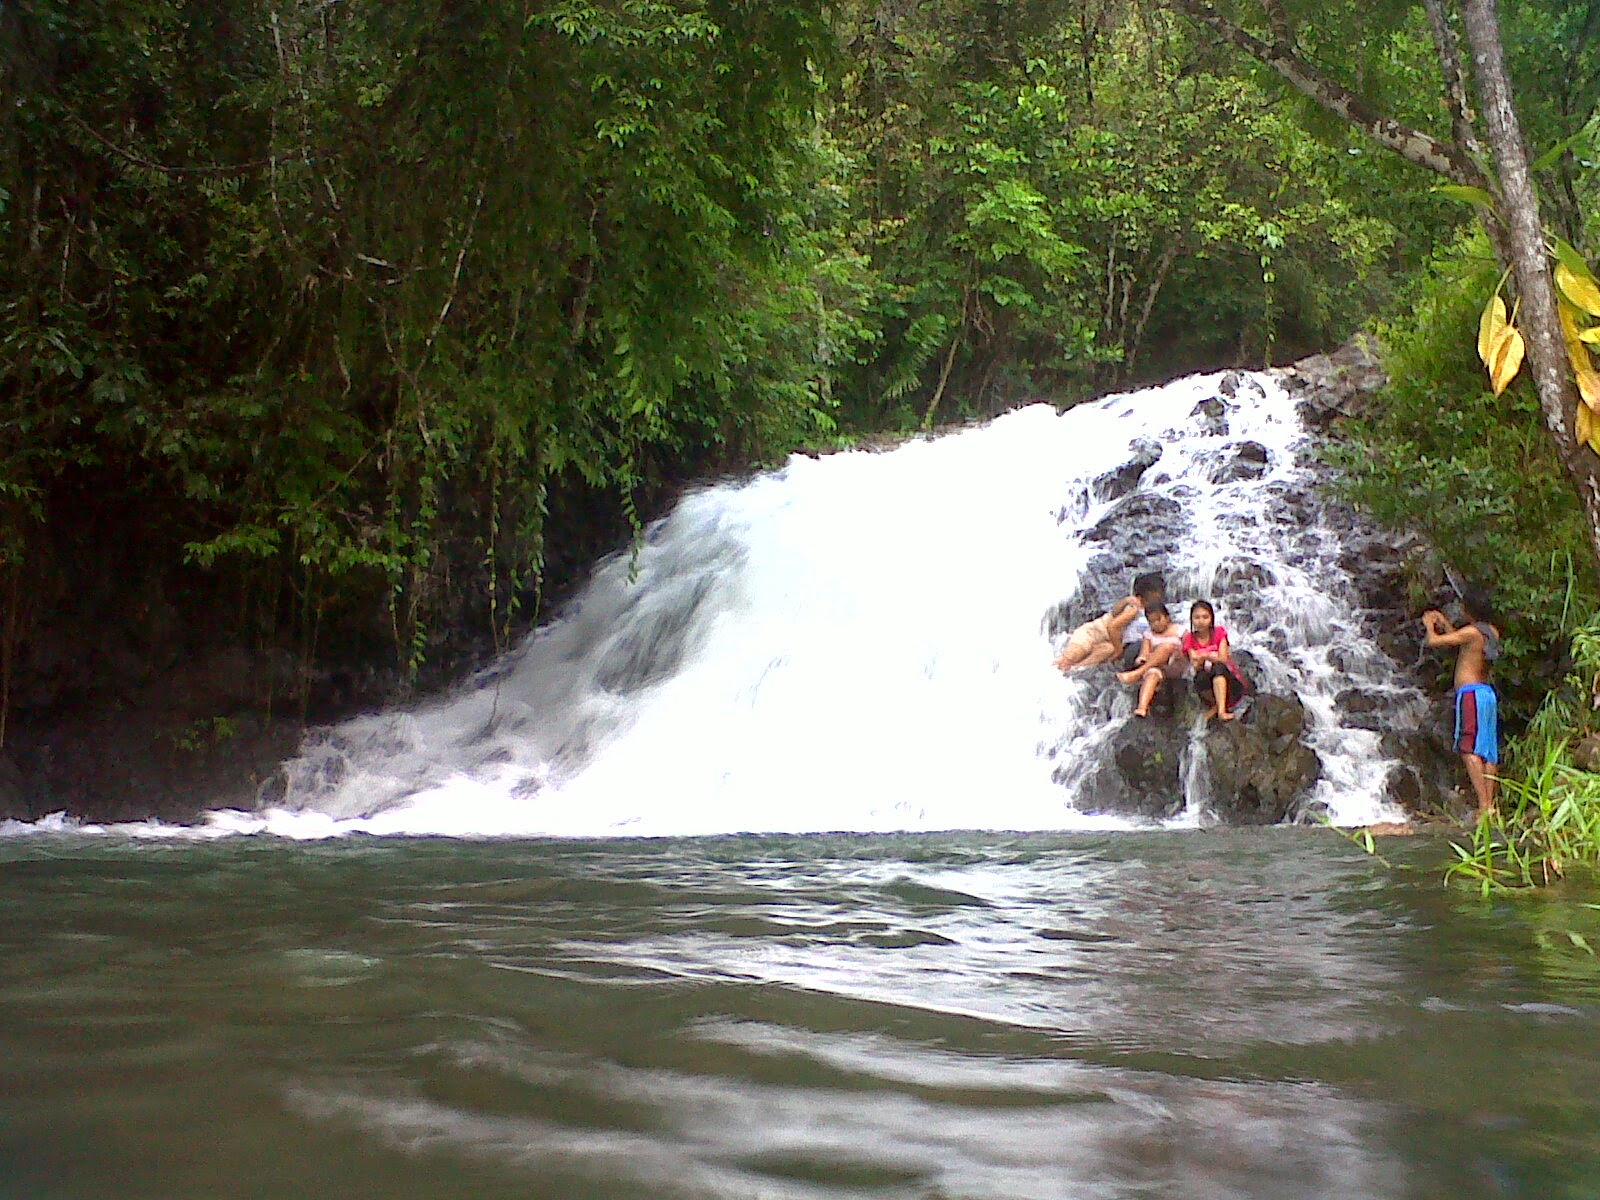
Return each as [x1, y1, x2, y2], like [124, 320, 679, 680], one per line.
[1205, 694, 1322, 826]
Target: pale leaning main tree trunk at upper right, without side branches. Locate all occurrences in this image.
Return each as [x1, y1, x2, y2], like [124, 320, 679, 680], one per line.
[1461, 0, 1600, 566]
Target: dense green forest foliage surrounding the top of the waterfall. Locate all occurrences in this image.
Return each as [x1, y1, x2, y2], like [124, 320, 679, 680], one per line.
[0, 0, 1600, 857]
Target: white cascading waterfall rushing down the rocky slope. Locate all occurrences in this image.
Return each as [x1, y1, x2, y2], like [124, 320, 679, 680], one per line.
[211, 374, 1426, 835]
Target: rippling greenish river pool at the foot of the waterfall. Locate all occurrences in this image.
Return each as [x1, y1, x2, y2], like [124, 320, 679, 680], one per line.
[0, 829, 1600, 1200]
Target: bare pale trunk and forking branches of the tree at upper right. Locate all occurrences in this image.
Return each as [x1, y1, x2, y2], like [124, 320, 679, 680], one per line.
[1165, 0, 1600, 566]
